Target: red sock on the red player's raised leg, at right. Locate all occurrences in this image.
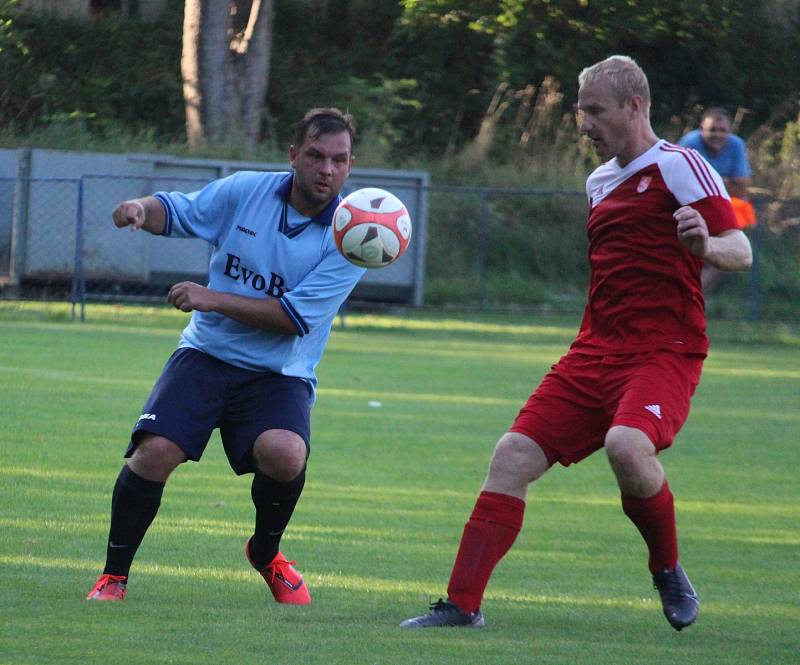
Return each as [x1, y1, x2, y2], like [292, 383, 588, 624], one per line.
[622, 480, 678, 574]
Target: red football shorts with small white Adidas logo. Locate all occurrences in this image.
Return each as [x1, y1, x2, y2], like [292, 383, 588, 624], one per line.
[510, 351, 703, 466]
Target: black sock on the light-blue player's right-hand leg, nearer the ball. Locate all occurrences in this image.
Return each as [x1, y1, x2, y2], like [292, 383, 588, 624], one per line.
[250, 468, 306, 569]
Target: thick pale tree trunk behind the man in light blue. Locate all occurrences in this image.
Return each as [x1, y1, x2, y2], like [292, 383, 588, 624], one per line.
[181, 0, 272, 149]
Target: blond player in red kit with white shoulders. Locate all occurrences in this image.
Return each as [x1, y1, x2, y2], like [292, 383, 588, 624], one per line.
[401, 55, 752, 630]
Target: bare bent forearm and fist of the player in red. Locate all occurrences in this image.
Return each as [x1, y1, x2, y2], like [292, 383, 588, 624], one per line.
[673, 206, 753, 271]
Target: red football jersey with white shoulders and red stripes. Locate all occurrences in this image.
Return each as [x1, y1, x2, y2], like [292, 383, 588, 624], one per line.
[572, 140, 737, 355]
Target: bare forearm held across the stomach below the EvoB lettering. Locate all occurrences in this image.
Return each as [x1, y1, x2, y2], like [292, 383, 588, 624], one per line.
[167, 282, 297, 335]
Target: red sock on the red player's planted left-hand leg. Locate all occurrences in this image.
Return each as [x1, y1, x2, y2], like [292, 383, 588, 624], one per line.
[447, 492, 525, 612]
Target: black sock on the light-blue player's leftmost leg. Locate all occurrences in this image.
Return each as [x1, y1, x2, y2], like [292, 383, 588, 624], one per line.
[103, 464, 164, 577]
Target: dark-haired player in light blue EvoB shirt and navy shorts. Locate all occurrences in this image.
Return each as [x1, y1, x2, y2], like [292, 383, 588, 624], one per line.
[87, 108, 364, 604]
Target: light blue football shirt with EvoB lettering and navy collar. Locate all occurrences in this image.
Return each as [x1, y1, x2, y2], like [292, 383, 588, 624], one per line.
[155, 171, 365, 400]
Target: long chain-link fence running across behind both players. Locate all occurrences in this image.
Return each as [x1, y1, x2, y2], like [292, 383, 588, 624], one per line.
[0, 175, 800, 320]
